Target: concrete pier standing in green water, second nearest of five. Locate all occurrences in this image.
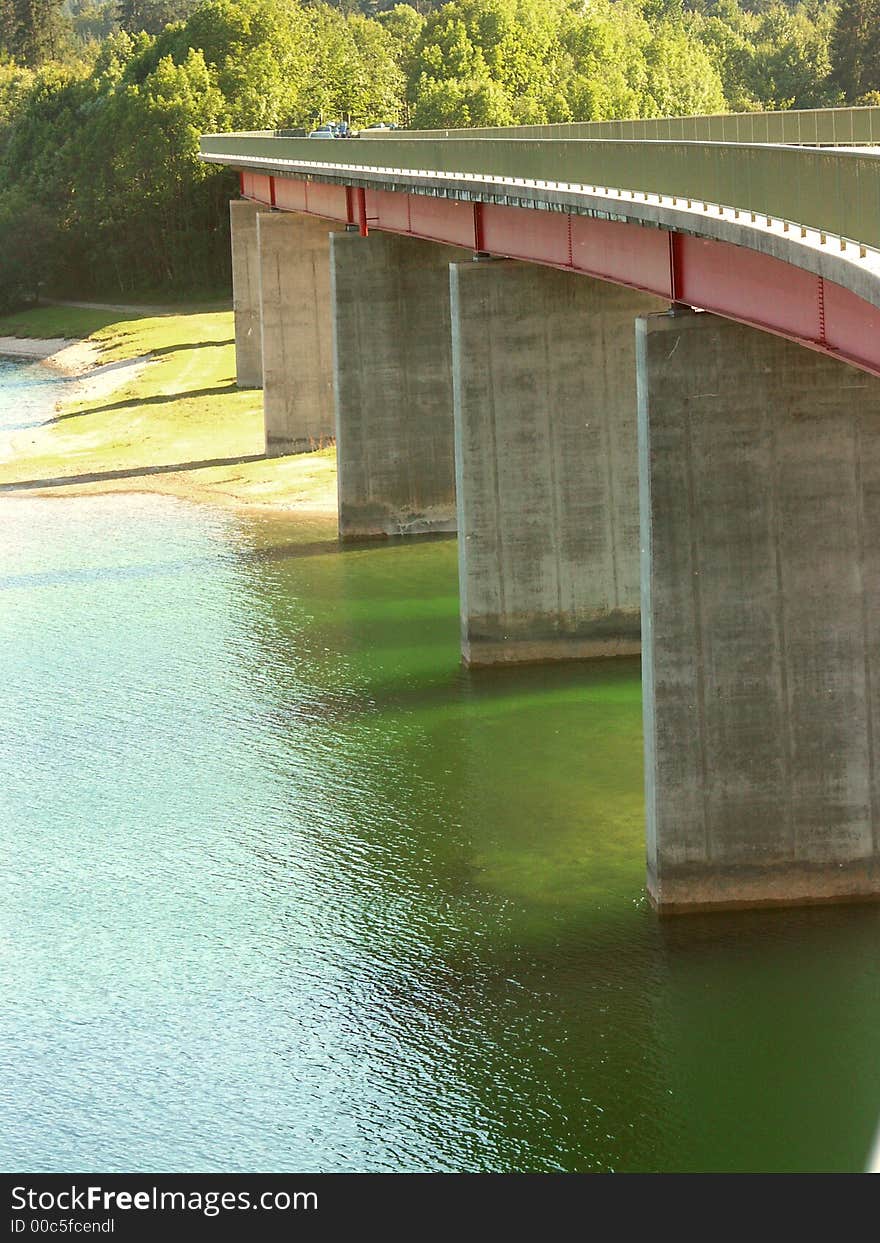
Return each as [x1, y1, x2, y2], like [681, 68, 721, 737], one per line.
[451, 261, 664, 665]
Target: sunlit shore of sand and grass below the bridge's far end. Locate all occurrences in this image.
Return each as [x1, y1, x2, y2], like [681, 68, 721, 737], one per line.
[0, 308, 337, 522]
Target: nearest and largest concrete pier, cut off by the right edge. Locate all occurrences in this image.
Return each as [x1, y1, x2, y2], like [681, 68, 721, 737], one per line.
[636, 313, 880, 911]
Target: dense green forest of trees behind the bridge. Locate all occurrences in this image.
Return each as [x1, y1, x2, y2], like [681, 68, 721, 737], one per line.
[0, 0, 880, 307]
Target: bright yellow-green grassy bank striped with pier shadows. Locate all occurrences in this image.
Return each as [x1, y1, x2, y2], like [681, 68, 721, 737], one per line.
[0, 307, 336, 513]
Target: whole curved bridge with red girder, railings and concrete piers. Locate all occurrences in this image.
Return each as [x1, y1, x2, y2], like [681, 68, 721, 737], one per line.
[201, 108, 880, 911]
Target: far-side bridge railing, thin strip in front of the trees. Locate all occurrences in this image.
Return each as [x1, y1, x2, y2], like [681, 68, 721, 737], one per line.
[352, 107, 880, 147]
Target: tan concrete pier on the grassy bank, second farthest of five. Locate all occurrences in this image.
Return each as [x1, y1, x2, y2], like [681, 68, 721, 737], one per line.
[257, 211, 339, 457]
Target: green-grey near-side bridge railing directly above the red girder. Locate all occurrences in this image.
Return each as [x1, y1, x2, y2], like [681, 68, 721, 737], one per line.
[201, 134, 880, 249]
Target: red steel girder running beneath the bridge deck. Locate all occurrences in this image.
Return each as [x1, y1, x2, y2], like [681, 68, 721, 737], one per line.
[240, 172, 880, 375]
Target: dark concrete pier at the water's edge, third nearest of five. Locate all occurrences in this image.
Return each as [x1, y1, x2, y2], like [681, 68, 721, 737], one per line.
[331, 232, 462, 538]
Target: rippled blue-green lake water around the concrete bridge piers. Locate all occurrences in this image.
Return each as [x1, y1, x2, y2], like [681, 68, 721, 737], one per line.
[0, 355, 880, 1171]
